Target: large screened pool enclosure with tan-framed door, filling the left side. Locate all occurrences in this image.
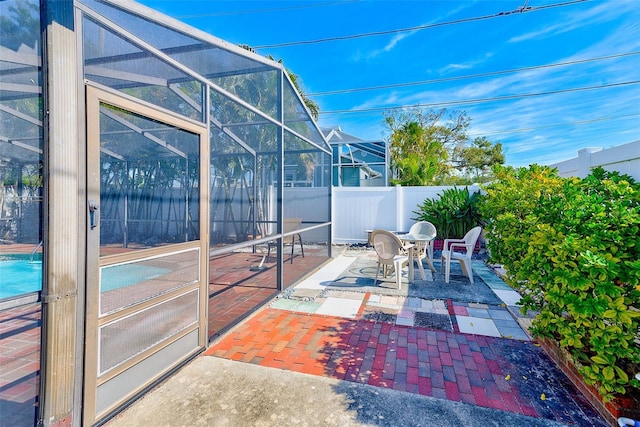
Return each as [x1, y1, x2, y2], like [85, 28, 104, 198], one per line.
[0, 0, 332, 425]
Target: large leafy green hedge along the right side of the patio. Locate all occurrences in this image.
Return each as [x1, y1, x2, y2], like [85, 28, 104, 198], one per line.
[481, 165, 640, 400]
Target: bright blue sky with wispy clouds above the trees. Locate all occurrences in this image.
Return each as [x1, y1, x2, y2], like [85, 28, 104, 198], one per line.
[140, 0, 640, 166]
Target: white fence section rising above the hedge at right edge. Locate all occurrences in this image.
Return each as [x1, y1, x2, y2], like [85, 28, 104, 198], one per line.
[550, 141, 640, 181]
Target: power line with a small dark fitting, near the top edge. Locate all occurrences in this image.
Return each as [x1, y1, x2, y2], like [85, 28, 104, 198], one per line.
[253, 0, 589, 50]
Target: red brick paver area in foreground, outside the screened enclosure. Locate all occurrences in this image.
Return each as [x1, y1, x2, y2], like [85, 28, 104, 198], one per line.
[205, 308, 604, 426]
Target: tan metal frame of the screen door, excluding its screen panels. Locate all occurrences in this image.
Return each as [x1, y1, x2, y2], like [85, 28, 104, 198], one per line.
[82, 83, 209, 425]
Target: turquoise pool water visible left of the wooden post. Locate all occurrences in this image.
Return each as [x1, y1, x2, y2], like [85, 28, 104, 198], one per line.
[0, 254, 42, 299]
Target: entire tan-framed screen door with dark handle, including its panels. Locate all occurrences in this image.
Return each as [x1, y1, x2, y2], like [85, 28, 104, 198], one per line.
[84, 86, 208, 423]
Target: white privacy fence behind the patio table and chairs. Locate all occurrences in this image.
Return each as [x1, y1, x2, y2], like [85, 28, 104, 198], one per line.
[331, 185, 479, 244]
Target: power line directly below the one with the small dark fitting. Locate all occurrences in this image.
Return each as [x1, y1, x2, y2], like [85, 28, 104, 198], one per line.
[306, 51, 640, 96]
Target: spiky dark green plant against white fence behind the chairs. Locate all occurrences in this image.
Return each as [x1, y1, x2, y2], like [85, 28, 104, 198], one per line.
[413, 187, 481, 239]
